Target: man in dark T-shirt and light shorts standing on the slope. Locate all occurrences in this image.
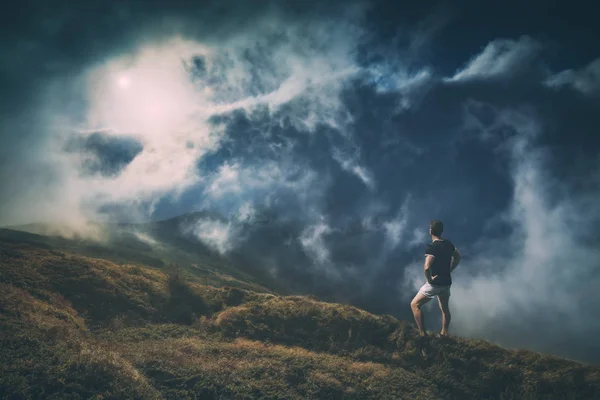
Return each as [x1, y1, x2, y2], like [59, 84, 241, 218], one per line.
[410, 220, 460, 336]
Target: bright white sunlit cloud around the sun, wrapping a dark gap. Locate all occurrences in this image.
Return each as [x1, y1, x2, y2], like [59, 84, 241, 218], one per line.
[51, 38, 218, 212]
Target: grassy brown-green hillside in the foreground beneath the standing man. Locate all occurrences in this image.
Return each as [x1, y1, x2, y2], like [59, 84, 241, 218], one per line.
[0, 238, 600, 400]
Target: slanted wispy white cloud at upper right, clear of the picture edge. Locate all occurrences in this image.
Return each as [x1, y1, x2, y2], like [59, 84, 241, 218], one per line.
[446, 36, 541, 82]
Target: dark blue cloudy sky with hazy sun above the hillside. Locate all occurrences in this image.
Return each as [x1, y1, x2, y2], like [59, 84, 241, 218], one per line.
[0, 0, 600, 363]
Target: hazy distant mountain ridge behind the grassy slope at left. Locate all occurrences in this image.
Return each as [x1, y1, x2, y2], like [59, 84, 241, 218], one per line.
[0, 212, 274, 291]
